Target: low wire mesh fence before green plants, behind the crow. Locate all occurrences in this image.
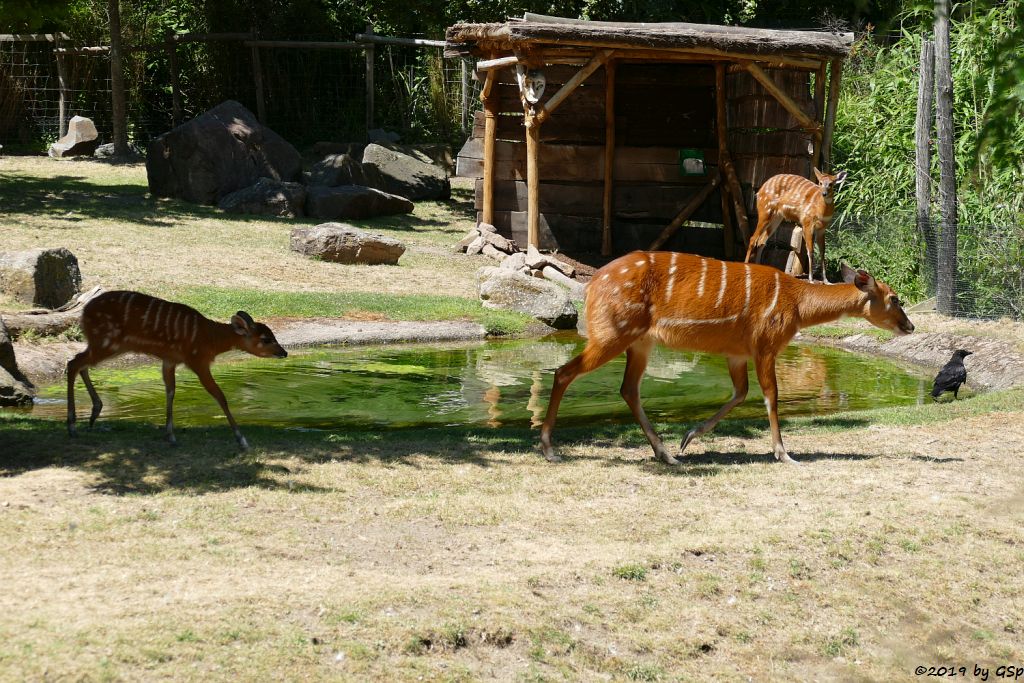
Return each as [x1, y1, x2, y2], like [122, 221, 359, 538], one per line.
[827, 213, 1024, 319]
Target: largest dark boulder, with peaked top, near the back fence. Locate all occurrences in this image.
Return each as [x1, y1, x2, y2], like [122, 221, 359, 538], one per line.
[145, 99, 302, 204]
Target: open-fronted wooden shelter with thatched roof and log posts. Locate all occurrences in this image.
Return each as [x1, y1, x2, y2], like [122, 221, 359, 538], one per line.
[445, 13, 853, 270]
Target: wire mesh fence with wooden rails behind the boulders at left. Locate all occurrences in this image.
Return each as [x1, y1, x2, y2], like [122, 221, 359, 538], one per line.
[0, 36, 479, 152]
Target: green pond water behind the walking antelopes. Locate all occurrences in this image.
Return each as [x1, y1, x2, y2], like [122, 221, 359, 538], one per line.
[31, 335, 929, 430]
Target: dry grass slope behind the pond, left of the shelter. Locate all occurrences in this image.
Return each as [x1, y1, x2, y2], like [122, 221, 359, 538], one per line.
[0, 157, 481, 308]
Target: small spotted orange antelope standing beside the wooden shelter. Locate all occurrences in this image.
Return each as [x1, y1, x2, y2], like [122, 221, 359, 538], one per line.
[743, 169, 846, 285]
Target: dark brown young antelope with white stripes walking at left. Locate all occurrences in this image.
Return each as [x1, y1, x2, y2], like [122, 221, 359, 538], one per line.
[68, 292, 288, 449]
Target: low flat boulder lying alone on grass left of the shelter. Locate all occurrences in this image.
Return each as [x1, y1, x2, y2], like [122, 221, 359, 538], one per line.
[292, 223, 406, 265]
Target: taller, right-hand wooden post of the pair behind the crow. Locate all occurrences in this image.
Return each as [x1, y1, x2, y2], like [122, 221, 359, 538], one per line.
[935, 0, 956, 315]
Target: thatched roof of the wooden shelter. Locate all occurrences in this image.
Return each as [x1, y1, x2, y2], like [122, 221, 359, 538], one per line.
[445, 13, 853, 58]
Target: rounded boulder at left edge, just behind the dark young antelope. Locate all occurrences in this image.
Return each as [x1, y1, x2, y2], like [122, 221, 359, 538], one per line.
[0, 247, 82, 308]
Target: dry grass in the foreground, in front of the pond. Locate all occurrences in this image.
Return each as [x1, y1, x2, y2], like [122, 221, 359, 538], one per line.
[0, 407, 1024, 681]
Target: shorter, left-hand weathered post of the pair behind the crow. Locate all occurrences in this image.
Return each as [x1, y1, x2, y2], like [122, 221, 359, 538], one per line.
[914, 37, 938, 294]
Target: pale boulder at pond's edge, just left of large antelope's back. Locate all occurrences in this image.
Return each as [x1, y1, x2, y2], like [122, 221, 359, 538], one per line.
[477, 267, 579, 330]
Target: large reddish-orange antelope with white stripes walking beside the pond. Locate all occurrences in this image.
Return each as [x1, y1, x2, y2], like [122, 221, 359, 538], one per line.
[541, 252, 913, 465]
